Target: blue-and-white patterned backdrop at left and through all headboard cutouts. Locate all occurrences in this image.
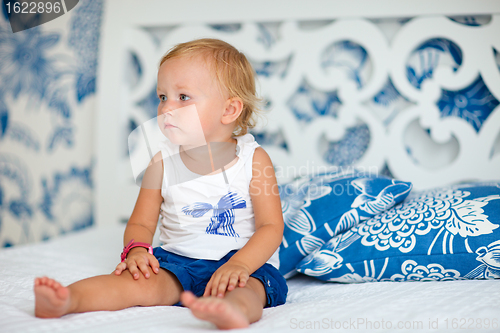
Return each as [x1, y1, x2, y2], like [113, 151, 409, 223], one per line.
[0, 7, 500, 246]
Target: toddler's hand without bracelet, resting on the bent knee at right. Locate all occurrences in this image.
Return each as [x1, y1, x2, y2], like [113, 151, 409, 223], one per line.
[203, 262, 250, 297]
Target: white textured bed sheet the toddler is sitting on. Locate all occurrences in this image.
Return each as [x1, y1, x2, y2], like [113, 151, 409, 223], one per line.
[0, 226, 500, 333]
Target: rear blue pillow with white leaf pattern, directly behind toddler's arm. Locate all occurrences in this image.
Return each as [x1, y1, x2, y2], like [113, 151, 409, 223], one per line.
[279, 171, 411, 278]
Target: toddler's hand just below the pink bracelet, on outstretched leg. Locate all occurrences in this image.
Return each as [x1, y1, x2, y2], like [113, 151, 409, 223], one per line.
[115, 247, 160, 280]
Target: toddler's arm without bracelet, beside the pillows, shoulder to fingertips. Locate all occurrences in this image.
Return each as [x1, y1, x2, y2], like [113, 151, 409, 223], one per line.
[203, 147, 284, 297]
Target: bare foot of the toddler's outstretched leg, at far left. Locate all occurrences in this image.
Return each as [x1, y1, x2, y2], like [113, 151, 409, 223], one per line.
[34, 277, 70, 318]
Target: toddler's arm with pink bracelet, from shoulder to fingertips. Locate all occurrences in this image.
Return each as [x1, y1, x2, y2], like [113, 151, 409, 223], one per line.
[115, 153, 163, 280]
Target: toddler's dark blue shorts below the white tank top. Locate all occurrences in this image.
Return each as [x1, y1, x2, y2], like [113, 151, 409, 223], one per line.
[153, 247, 288, 307]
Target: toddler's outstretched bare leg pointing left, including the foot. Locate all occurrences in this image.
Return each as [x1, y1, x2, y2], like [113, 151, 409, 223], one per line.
[34, 268, 182, 318]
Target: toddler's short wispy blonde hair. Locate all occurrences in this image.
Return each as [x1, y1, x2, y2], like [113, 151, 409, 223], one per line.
[160, 38, 262, 136]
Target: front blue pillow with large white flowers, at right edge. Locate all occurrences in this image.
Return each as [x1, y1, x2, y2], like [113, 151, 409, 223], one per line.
[297, 182, 500, 282]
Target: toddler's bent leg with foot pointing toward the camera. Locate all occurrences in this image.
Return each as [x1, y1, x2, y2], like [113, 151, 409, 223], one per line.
[181, 277, 266, 329]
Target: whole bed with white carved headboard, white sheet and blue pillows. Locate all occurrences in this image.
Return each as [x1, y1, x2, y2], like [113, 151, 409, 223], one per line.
[0, 0, 500, 332]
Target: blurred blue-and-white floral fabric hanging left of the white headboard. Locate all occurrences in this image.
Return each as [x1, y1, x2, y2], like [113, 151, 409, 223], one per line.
[0, 0, 103, 247]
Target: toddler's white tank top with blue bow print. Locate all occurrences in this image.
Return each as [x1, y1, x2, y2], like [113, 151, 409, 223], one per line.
[160, 134, 279, 268]
